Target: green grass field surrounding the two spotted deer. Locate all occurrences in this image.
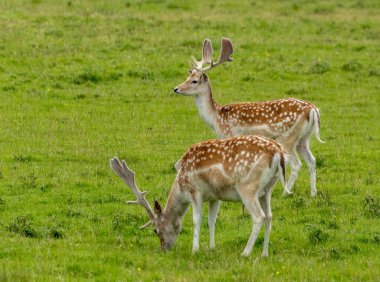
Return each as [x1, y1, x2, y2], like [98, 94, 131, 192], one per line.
[0, 0, 380, 281]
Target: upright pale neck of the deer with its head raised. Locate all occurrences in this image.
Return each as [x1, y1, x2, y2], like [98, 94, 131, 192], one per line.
[195, 84, 219, 131]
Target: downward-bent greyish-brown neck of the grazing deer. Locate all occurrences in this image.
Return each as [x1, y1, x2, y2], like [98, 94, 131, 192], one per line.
[164, 180, 190, 223]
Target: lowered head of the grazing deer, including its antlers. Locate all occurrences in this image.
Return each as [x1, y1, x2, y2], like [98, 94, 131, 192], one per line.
[110, 157, 181, 250]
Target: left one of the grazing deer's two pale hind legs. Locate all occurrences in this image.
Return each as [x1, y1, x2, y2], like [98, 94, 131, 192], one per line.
[238, 184, 265, 256]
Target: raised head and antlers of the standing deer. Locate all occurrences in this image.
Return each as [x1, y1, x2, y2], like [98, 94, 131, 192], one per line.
[174, 38, 233, 95]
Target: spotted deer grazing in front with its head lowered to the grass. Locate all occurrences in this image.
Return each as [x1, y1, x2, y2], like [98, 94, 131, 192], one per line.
[110, 136, 286, 256]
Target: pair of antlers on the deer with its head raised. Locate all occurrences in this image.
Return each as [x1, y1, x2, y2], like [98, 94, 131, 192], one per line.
[191, 38, 234, 72]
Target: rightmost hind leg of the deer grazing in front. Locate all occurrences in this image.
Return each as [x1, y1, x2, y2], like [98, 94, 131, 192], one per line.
[259, 177, 278, 257]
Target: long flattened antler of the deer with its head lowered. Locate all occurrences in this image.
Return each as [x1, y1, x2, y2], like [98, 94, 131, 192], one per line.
[110, 157, 155, 222]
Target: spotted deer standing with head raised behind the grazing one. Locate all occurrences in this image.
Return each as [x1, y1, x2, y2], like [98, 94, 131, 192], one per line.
[174, 38, 324, 196]
